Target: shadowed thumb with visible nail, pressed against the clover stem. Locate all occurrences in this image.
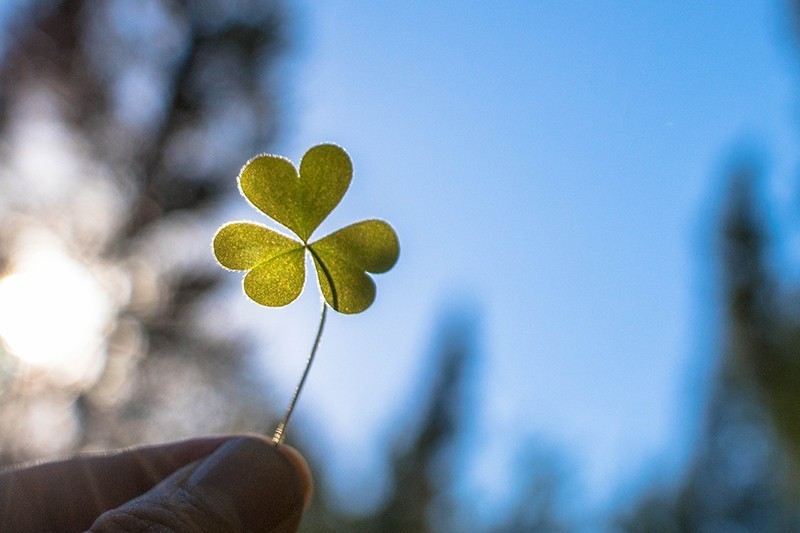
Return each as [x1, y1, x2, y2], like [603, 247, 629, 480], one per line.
[90, 437, 311, 533]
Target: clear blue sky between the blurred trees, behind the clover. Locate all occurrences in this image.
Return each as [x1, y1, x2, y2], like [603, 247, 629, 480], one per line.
[228, 0, 800, 516]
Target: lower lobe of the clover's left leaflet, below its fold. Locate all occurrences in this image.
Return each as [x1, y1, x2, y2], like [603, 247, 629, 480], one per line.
[244, 243, 306, 307]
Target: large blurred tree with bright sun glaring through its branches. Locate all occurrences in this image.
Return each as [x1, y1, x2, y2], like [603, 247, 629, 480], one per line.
[0, 0, 283, 463]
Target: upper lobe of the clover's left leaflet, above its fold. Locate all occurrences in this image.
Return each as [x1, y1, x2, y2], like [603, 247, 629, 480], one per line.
[213, 222, 303, 270]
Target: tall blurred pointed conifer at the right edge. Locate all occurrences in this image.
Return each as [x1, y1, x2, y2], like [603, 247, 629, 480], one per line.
[621, 169, 800, 531]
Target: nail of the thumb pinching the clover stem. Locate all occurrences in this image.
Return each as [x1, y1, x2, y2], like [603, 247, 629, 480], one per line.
[184, 437, 306, 531]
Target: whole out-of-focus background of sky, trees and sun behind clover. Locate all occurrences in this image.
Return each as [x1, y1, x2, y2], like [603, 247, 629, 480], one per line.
[0, 0, 800, 532]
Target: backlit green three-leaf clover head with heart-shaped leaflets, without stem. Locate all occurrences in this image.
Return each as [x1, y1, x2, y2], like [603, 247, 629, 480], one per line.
[214, 144, 400, 314]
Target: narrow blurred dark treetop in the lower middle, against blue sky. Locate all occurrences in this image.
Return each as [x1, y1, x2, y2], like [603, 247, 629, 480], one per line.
[303, 315, 476, 533]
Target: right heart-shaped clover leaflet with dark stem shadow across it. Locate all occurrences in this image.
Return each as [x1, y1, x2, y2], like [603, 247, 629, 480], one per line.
[308, 220, 400, 314]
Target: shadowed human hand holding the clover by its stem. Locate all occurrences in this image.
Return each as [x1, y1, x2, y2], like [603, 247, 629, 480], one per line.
[0, 436, 312, 533]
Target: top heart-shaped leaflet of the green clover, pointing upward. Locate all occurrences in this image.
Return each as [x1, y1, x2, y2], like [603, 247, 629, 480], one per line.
[239, 144, 353, 242]
